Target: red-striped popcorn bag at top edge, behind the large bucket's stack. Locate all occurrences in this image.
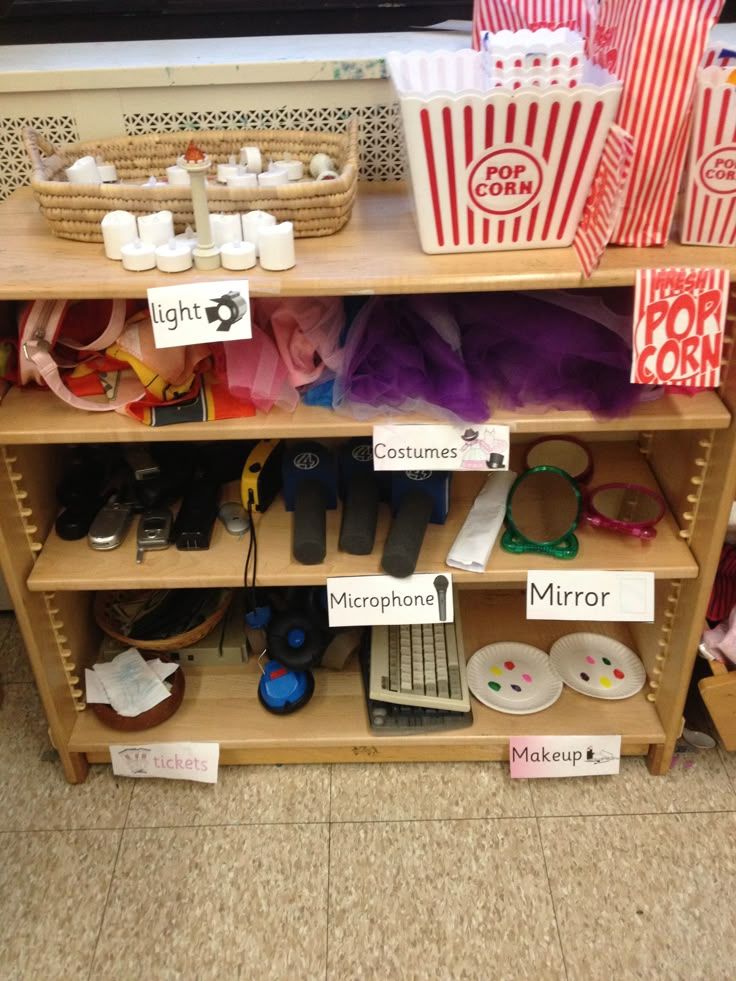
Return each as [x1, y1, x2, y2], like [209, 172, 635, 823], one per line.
[473, 0, 598, 51]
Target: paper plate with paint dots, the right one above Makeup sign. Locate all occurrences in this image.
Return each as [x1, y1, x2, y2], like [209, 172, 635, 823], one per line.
[549, 634, 647, 698]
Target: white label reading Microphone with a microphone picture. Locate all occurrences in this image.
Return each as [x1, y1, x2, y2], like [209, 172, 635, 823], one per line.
[327, 572, 455, 627]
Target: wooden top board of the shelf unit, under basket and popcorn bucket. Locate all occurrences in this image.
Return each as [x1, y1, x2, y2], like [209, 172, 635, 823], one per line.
[0, 182, 736, 299]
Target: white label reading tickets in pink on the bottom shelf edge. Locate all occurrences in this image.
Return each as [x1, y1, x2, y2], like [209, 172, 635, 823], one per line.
[110, 743, 220, 783]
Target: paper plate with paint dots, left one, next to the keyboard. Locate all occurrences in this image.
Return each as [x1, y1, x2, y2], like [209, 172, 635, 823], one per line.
[466, 641, 562, 715]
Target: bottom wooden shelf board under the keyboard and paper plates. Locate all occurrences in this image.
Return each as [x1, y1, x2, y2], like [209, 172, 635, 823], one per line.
[69, 591, 664, 763]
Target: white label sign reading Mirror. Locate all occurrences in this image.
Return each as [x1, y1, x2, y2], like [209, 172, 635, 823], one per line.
[526, 569, 654, 623]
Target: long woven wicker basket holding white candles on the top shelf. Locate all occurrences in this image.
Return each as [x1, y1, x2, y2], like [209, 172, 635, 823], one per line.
[23, 118, 358, 242]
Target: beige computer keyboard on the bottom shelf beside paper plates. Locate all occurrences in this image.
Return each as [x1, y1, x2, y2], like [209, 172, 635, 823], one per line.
[368, 623, 470, 712]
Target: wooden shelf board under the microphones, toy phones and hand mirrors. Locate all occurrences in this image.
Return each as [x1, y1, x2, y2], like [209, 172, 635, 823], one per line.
[28, 441, 698, 591]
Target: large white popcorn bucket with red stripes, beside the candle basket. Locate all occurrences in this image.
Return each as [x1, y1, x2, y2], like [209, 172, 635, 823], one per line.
[387, 52, 621, 253]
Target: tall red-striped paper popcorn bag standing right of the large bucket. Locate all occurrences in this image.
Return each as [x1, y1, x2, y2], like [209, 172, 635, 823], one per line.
[590, 0, 723, 246]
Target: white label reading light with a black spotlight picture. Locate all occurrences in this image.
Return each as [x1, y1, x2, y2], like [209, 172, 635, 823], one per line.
[148, 279, 251, 347]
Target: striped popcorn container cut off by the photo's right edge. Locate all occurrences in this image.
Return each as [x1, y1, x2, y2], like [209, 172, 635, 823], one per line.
[680, 67, 736, 245]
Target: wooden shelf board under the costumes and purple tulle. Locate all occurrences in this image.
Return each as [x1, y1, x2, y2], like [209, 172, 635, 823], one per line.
[0, 389, 731, 445]
